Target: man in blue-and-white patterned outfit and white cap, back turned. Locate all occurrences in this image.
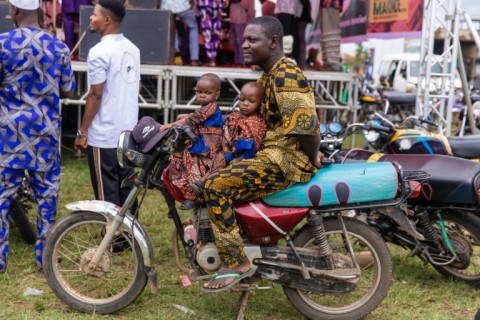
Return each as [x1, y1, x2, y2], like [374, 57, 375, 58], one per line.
[0, 0, 75, 272]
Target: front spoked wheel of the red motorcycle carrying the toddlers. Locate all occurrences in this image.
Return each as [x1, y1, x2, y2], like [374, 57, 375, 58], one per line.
[43, 211, 147, 314]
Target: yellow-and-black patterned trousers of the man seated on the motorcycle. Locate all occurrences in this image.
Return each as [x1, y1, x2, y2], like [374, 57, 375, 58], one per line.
[204, 157, 292, 268]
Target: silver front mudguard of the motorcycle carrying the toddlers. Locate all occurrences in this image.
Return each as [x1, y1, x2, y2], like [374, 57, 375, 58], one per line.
[66, 200, 154, 268]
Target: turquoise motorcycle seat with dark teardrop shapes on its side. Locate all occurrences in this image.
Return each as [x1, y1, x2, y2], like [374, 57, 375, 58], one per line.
[262, 162, 398, 207]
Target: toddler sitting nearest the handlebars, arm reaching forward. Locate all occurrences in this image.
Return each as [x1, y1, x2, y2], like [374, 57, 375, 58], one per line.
[160, 73, 226, 210]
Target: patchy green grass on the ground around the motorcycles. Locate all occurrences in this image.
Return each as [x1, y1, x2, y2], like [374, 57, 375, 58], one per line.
[0, 146, 480, 320]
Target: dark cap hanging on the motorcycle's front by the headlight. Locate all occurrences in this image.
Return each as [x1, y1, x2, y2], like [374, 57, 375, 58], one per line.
[132, 117, 168, 152]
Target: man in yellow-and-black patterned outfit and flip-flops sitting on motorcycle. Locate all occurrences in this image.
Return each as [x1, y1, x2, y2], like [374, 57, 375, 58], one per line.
[203, 16, 321, 292]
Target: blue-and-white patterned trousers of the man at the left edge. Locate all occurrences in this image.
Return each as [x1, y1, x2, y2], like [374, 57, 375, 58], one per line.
[0, 165, 60, 271]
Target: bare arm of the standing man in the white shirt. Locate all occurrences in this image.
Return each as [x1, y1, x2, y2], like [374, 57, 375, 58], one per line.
[75, 82, 105, 149]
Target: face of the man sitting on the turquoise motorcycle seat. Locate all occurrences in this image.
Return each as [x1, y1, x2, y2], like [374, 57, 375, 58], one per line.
[242, 24, 272, 65]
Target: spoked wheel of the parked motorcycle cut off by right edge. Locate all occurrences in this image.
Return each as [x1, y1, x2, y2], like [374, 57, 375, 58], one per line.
[430, 210, 480, 287]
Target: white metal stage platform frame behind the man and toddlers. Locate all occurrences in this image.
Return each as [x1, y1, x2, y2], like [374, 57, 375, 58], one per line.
[63, 61, 358, 124]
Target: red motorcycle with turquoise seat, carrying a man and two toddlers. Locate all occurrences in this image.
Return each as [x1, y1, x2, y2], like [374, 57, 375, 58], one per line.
[43, 127, 420, 319]
